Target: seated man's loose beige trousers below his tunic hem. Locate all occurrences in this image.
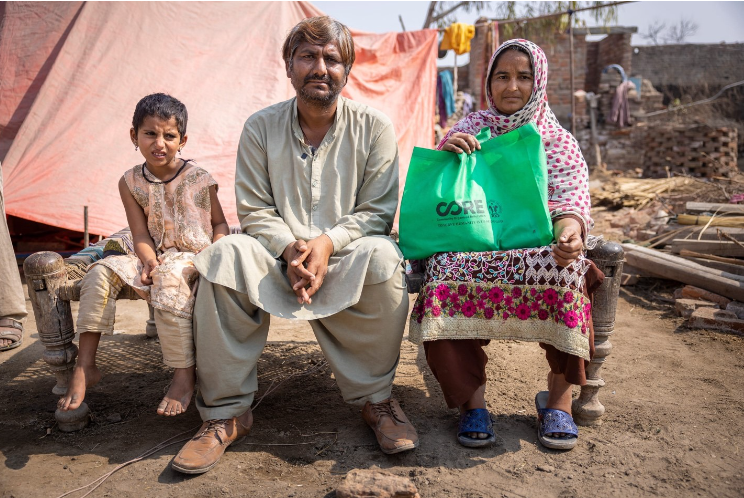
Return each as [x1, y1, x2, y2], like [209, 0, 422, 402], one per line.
[194, 265, 408, 420]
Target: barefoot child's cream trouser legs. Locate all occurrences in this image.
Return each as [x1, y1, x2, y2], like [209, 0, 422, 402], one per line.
[77, 265, 196, 368]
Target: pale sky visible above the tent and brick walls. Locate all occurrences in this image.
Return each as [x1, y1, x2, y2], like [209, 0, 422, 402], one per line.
[312, 1, 744, 65]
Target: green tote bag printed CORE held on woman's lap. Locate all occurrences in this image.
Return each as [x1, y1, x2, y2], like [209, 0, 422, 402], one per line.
[399, 123, 553, 259]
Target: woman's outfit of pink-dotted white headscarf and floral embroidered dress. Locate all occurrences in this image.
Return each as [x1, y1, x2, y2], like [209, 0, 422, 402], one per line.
[409, 39, 602, 366]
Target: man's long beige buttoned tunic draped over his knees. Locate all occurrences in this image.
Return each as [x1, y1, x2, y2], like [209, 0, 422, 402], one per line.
[194, 97, 403, 320]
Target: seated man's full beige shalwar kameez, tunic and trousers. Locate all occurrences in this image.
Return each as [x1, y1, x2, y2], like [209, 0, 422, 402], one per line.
[194, 97, 408, 420]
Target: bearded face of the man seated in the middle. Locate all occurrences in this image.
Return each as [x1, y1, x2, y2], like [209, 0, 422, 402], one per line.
[287, 42, 346, 107]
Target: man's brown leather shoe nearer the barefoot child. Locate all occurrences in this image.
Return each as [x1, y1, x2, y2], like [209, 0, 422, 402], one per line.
[171, 417, 250, 474]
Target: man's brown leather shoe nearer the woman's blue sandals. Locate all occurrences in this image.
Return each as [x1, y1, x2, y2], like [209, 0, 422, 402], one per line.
[362, 398, 418, 455]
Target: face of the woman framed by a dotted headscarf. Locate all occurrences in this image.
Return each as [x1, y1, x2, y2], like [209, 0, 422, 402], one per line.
[490, 49, 534, 116]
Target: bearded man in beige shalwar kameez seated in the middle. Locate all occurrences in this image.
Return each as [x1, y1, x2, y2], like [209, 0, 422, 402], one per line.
[172, 17, 418, 474]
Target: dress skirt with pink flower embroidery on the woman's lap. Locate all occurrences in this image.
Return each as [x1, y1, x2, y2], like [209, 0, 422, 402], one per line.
[409, 246, 593, 361]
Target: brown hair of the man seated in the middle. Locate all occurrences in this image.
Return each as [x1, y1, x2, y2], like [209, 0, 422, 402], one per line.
[282, 16, 354, 76]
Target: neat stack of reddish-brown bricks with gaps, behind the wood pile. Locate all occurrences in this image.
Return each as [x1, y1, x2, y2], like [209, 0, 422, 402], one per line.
[643, 125, 738, 178]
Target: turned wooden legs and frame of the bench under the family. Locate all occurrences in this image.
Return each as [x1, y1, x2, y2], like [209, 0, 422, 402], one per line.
[23, 230, 623, 432]
